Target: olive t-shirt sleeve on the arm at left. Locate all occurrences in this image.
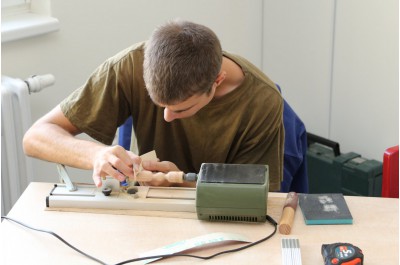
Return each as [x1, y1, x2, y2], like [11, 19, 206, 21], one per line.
[60, 57, 131, 144]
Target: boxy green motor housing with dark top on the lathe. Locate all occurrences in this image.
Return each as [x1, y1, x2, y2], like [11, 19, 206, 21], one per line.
[196, 163, 269, 222]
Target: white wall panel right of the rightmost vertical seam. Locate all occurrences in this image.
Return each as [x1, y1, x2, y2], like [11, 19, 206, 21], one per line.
[330, 0, 399, 160]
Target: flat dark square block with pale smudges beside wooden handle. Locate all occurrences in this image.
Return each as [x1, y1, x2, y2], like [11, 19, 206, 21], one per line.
[299, 193, 353, 225]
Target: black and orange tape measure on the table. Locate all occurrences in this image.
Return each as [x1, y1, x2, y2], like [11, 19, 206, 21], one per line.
[321, 243, 364, 265]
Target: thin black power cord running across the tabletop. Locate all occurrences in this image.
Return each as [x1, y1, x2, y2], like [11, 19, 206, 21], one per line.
[1, 215, 278, 265]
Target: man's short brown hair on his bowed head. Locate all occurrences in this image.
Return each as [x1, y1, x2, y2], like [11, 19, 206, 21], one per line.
[143, 20, 222, 104]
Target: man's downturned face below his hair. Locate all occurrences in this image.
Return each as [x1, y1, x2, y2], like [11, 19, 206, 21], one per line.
[159, 85, 215, 122]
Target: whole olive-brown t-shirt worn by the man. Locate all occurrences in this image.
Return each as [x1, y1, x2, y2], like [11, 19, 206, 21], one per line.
[61, 42, 284, 191]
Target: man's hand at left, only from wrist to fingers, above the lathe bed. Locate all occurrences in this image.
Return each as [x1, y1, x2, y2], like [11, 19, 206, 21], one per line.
[93, 145, 141, 187]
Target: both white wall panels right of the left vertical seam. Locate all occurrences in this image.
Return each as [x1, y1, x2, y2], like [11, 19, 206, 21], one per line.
[263, 0, 399, 161]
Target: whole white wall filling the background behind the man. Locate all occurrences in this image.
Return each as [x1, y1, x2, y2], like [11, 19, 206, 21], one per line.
[2, 0, 399, 184]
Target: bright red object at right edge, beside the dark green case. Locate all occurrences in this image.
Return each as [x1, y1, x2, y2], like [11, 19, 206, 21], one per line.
[382, 145, 399, 198]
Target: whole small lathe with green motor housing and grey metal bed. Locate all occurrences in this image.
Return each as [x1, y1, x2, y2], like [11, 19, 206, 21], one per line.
[46, 163, 269, 222]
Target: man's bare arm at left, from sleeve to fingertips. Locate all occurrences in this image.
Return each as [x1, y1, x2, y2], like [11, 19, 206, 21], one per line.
[23, 106, 140, 187]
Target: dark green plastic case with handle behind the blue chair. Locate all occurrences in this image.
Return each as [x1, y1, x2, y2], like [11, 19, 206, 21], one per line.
[307, 133, 382, 197]
